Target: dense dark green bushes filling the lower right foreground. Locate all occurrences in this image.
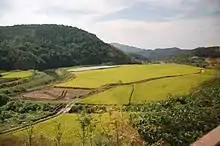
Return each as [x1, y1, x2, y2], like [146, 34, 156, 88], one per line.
[130, 78, 220, 146]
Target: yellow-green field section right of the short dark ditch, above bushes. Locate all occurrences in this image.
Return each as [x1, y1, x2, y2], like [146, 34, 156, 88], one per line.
[132, 74, 212, 103]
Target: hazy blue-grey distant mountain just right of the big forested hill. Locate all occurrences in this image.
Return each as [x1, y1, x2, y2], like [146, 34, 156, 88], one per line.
[111, 43, 185, 61]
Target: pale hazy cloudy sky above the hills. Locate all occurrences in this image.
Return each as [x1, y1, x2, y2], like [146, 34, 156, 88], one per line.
[0, 0, 220, 48]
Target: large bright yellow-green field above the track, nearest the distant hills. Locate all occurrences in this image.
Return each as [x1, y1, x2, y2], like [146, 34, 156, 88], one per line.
[56, 64, 200, 88]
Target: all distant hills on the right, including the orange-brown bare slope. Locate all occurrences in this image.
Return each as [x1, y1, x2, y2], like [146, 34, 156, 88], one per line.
[111, 43, 220, 67]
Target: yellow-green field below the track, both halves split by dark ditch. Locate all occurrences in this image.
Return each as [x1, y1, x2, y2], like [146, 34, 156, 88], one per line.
[79, 73, 213, 104]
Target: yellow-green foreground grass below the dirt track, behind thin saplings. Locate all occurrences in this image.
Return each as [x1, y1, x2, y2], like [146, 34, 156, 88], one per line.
[10, 113, 110, 143]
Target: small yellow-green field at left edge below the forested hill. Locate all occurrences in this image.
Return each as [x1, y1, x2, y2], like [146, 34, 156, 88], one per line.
[1, 71, 33, 78]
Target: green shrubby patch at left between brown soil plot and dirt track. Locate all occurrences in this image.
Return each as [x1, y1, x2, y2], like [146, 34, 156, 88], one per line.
[0, 100, 61, 133]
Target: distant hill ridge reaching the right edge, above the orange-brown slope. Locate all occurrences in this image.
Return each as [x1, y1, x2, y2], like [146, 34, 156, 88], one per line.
[111, 43, 220, 61]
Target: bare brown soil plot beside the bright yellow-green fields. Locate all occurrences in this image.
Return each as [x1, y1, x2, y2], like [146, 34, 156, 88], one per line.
[16, 87, 91, 100]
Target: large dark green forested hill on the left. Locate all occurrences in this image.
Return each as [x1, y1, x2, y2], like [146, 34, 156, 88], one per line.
[0, 25, 131, 70]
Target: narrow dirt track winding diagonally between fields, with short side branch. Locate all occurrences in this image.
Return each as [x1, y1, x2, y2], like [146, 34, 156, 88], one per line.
[0, 71, 202, 135]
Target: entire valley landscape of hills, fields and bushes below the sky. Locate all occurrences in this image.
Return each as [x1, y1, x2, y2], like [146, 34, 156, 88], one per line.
[0, 24, 220, 146]
